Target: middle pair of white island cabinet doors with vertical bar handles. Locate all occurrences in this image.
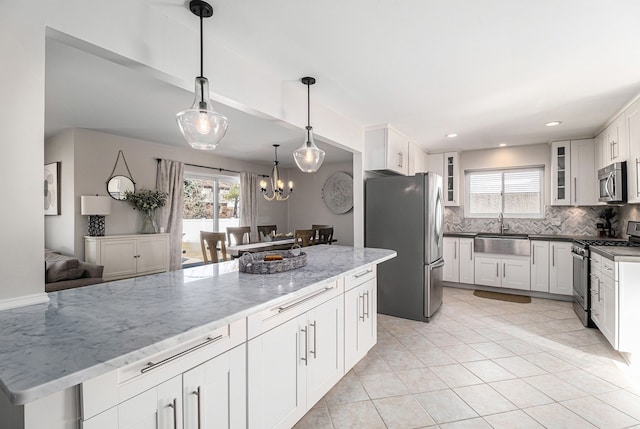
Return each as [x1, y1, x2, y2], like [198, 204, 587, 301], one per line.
[247, 293, 344, 428]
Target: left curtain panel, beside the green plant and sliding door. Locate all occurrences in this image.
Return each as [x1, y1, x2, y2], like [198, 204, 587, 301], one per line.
[156, 159, 184, 271]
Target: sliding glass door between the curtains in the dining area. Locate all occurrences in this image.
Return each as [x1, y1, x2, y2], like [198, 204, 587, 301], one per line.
[182, 173, 240, 267]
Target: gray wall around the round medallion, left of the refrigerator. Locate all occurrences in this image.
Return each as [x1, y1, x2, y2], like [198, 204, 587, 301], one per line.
[288, 163, 354, 246]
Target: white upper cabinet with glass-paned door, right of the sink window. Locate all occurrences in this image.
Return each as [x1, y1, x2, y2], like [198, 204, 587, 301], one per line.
[551, 139, 598, 206]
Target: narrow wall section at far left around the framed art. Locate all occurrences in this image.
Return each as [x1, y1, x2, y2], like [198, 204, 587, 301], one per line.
[44, 130, 79, 255]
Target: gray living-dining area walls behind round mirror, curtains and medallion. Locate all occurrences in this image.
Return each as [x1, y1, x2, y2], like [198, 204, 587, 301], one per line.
[45, 129, 353, 259]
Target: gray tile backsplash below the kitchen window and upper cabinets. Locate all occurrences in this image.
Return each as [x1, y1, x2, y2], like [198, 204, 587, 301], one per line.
[444, 206, 620, 236]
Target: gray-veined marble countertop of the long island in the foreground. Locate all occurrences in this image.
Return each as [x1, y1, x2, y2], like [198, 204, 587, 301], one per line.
[0, 245, 396, 405]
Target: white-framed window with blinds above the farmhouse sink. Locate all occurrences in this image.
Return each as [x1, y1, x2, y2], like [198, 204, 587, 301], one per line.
[465, 167, 544, 218]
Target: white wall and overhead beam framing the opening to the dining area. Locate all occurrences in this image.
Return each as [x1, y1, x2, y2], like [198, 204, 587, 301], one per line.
[0, 0, 363, 301]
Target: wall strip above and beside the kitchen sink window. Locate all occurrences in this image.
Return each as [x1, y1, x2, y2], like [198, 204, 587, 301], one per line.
[459, 143, 551, 205]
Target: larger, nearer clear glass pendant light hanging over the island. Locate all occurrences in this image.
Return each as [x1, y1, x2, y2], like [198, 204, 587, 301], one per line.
[176, 0, 229, 150]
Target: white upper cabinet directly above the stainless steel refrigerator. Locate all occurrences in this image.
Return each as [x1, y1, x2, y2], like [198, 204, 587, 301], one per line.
[364, 127, 409, 176]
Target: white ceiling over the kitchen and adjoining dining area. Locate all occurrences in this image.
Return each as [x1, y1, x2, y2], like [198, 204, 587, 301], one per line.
[46, 0, 640, 165]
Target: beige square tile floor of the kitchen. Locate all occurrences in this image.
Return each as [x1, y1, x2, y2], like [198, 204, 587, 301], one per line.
[295, 288, 640, 429]
